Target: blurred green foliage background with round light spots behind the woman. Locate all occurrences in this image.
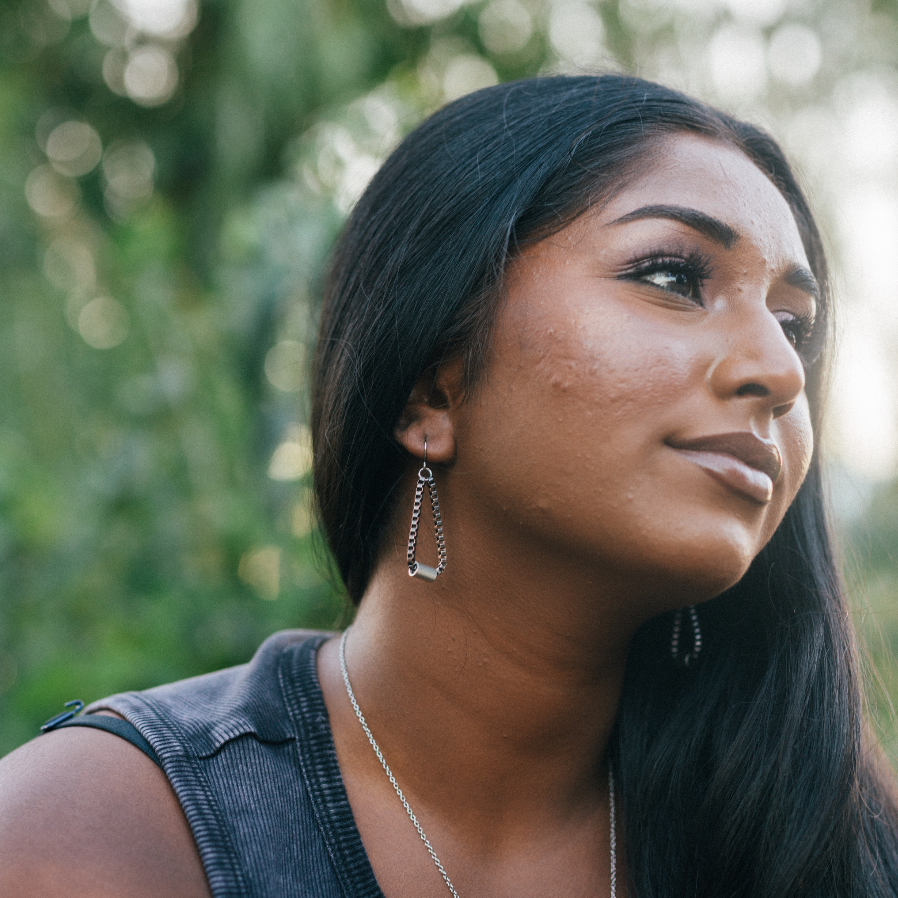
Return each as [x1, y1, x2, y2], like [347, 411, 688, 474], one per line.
[0, 0, 898, 754]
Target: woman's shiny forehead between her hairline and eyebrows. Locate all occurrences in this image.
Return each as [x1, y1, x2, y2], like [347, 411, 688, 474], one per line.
[593, 134, 807, 265]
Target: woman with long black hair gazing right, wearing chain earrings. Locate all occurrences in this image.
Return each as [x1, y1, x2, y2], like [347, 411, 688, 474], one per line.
[0, 76, 898, 898]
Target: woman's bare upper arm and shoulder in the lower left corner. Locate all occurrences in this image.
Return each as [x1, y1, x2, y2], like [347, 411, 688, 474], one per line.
[0, 727, 210, 898]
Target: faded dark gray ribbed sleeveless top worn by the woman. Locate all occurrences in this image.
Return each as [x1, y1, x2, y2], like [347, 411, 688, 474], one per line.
[87, 630, 384, 898]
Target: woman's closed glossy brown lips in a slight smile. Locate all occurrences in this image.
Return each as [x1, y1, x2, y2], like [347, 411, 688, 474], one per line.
[667, 432, 783, 505]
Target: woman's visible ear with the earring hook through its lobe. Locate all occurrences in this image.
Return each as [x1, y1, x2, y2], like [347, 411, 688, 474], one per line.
[393, 359, 463, 464]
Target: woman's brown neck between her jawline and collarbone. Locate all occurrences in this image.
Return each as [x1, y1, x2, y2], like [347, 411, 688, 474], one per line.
[319, 452, 694, 844]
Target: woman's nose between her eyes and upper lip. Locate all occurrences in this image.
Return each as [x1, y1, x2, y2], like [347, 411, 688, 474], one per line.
[708, 304, 805, 418]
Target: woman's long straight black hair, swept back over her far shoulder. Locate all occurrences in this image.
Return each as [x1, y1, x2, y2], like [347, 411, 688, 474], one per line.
[312, 75, 898, 898]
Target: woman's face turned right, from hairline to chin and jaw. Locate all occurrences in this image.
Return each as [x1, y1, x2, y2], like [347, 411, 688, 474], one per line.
[453, 135, 816, 604]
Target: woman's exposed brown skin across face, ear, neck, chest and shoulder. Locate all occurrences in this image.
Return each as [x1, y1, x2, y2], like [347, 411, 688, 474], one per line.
[0, 136, 813, 898]
